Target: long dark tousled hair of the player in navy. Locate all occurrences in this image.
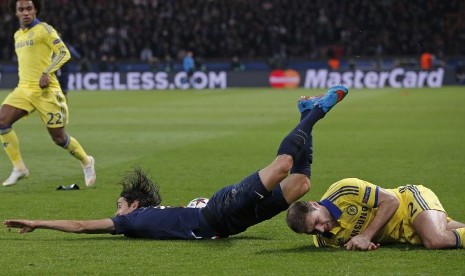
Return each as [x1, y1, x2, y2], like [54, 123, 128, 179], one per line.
[120, 168, 161, 207]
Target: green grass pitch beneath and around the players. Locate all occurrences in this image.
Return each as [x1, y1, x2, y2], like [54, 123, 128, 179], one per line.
[0, 87, 465, 275]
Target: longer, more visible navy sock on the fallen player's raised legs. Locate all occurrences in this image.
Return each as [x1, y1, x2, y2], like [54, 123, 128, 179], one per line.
[278, 106, 326, 163]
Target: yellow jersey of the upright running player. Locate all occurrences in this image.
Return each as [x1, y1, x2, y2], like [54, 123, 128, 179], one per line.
[14, 19, 71, 88]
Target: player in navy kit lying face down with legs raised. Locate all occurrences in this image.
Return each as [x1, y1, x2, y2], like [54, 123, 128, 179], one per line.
[4, 86, 348, 239]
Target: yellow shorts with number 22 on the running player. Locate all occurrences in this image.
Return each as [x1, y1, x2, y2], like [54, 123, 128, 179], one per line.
[3, 87, 68, 128]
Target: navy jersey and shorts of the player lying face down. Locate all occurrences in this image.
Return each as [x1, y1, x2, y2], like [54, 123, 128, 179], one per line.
[112, 172, 289, 240]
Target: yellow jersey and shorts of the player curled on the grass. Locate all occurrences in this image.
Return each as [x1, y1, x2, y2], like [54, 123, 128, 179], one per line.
[313, 178, 449, 247]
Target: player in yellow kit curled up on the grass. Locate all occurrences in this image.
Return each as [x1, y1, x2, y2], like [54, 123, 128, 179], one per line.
[286, 178, 465, 250]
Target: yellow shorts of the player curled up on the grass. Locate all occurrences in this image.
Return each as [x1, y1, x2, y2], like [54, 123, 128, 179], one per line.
[398, 185, 450, 244]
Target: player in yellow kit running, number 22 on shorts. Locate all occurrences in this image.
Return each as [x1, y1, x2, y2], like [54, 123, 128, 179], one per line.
[0, 0, 96, 186]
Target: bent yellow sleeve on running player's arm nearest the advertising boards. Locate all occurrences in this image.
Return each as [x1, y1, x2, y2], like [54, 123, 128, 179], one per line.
[43, 23, 71, 74]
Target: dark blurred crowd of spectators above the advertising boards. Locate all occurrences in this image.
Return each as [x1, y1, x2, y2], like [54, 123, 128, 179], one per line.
[0, 0, 465, 71]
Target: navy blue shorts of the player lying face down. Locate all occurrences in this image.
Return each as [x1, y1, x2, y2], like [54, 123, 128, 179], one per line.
[202, 172, 289, 237]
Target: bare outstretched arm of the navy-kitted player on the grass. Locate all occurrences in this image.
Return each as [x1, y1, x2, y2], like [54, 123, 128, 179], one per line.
[3, 218, 115, 234]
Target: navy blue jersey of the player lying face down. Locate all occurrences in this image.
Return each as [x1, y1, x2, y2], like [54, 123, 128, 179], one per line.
[111, 206, 217, 240]
